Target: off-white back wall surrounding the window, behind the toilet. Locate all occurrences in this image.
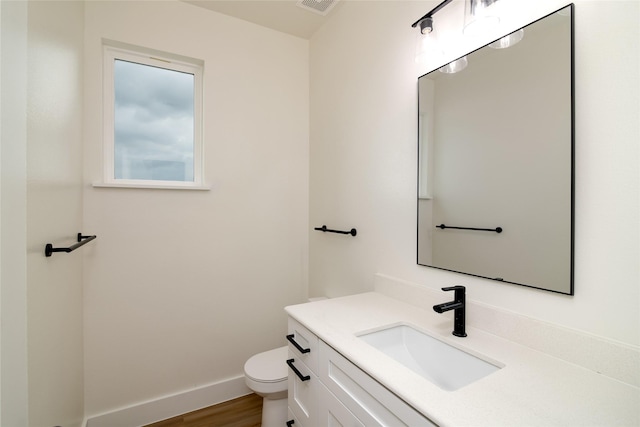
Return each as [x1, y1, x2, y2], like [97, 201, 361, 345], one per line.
[84, 1, 309, 416]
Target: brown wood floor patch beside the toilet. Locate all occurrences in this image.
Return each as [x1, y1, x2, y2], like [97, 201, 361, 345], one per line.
[145, 394, 262, 427]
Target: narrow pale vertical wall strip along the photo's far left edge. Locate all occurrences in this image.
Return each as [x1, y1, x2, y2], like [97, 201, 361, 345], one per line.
[0, 1, 28, 426]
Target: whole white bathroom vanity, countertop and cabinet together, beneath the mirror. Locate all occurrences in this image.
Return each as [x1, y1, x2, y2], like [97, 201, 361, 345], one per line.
[286, 282, 640, 427]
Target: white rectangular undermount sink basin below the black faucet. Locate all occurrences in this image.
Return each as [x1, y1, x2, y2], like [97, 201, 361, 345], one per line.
[359, 325, 500, 391]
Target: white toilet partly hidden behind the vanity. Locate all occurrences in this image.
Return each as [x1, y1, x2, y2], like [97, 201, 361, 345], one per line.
[244, 346, 288, 427]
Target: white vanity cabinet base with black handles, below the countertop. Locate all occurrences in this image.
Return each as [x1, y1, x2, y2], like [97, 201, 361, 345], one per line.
[287, 318, 435, 427]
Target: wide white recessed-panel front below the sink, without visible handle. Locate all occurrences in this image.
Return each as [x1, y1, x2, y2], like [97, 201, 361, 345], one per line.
[319, 341, 435, 427]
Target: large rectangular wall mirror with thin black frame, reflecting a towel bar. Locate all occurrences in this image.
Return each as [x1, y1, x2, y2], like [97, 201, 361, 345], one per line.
[418, 5, 574, 295]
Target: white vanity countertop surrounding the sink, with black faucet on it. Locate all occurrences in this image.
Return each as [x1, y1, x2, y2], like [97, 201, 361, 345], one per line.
[286, 292, 640, 427]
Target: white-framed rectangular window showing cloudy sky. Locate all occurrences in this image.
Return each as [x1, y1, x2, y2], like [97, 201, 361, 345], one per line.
[104, 45, 203, 188]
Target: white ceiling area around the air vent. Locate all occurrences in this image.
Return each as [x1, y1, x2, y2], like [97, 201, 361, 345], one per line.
[182, 0, 340, 39]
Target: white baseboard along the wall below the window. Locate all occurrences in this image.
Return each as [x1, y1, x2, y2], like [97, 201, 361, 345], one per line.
[84, 376, 251, 427]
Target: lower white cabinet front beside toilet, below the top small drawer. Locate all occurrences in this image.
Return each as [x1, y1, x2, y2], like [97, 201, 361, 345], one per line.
[287, 348, 319, 427]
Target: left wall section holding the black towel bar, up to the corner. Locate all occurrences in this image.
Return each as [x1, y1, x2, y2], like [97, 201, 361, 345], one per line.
[27, 1, 84, 426]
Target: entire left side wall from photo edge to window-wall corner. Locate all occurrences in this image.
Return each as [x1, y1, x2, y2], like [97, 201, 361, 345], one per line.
[0, 1, 84, 426]
